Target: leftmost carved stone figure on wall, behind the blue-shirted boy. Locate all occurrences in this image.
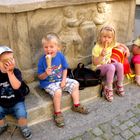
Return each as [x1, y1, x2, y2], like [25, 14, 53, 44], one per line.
[59, 7, 83, 66]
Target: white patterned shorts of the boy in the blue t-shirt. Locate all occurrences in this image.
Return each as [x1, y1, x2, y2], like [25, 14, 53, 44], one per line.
[44, 78, 79, 96]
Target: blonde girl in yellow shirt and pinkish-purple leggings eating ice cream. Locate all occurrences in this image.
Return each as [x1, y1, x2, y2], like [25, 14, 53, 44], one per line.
[92, 26, 129, 102]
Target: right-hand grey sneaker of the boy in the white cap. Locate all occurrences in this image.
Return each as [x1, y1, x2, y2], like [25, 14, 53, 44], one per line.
[20, 126, 32, 140]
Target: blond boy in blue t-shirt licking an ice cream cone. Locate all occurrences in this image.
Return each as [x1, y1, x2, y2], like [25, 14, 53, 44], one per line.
[38, 34, 88, 127]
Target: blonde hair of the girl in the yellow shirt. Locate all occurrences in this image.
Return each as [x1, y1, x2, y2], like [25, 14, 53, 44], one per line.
[97, 26, 116, 45]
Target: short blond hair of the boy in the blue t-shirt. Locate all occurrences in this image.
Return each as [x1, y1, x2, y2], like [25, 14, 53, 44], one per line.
[42, 33, 61, 46]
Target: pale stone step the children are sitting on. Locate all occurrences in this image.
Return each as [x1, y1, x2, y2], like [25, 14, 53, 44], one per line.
[6, 78, 132, 126]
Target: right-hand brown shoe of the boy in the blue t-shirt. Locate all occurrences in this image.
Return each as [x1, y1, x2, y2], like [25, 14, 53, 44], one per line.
[71, 105, 89, 114]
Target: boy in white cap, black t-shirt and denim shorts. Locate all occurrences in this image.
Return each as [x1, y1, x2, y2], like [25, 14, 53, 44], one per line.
[0, 46, 32, 139]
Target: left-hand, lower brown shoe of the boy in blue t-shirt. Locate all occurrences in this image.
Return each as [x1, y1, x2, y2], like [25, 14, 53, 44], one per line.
[54, 113, 65, 127]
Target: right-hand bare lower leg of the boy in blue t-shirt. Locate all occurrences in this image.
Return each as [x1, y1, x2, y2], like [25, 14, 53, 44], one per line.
[71, 84, 79, 104]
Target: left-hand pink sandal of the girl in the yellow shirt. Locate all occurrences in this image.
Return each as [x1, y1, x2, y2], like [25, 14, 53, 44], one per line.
[104, 87, 113, 102]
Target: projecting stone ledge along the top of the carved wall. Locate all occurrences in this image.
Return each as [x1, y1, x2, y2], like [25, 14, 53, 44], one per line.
[0, 0, 114, 13]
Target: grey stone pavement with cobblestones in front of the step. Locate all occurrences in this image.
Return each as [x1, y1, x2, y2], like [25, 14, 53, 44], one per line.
[0, 84, 140, 140]
